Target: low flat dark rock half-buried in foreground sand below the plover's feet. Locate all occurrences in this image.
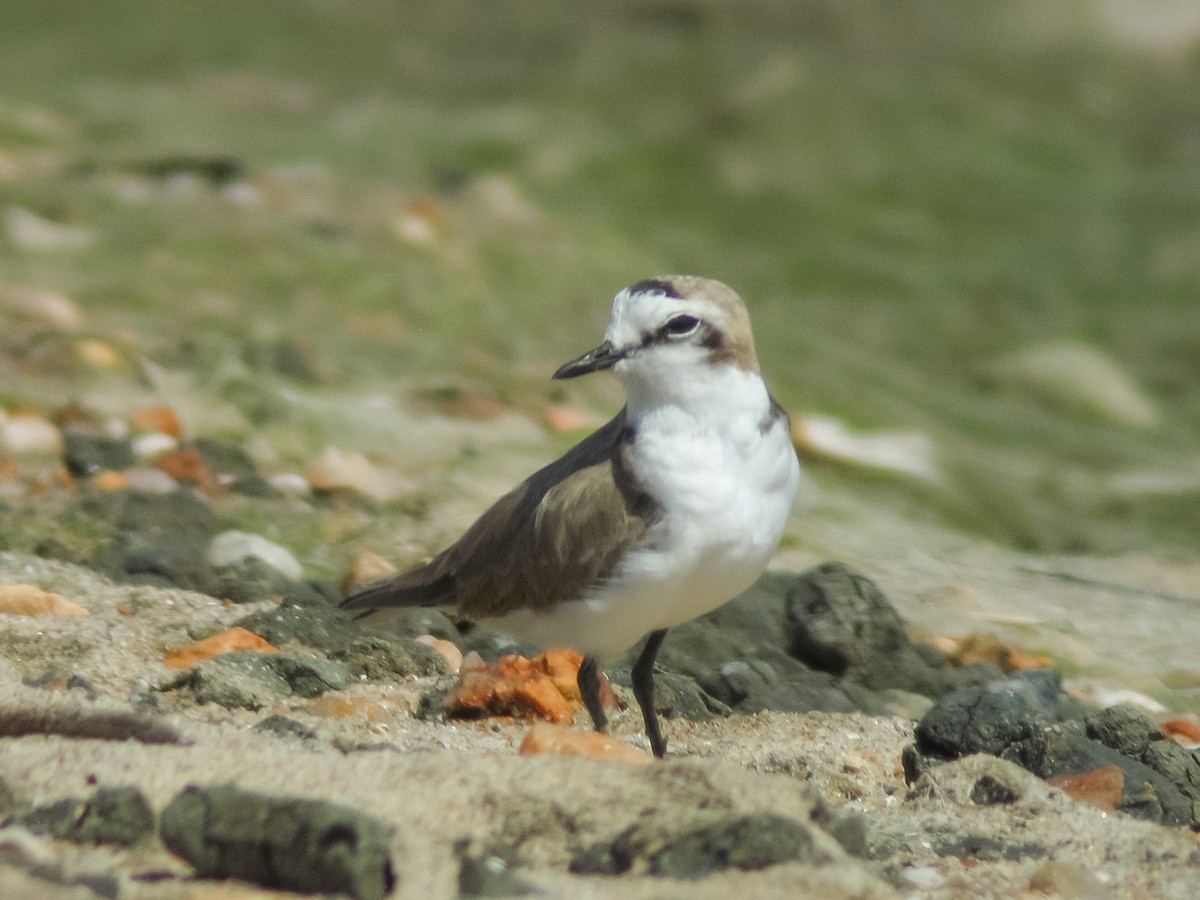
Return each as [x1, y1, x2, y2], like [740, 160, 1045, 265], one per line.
[571, 812, 826, 878]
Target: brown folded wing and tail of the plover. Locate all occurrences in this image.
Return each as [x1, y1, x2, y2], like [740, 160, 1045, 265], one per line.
[342, 410, 650, 618]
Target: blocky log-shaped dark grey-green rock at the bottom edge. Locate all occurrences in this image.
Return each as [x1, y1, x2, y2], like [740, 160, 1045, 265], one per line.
[158, 785, 396, 900]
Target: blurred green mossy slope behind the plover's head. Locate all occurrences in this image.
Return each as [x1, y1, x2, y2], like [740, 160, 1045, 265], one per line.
[0, 0, 1200, 552]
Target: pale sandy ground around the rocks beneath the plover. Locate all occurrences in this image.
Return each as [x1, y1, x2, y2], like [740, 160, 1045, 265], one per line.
[0, 494, 1200, 900]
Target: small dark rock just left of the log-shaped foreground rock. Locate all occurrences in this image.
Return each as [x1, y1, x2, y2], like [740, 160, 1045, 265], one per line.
[18, 787, 154, 847]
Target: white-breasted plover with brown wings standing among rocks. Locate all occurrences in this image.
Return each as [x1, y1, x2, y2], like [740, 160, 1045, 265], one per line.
[342, 276, 799, 757]
